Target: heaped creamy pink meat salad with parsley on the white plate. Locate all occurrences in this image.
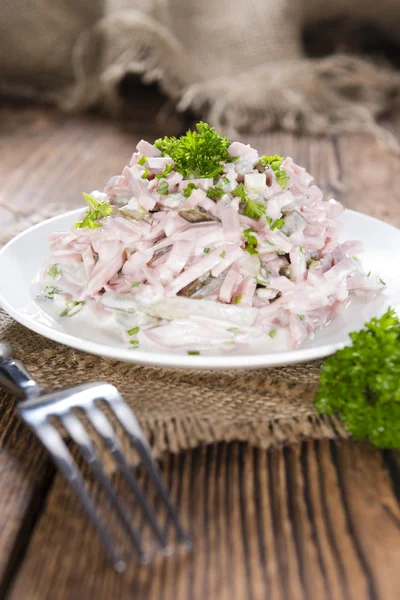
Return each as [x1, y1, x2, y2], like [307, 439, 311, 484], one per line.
[39, 123, 384, 354]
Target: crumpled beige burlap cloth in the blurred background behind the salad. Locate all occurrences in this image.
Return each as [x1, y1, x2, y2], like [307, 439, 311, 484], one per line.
[0, 0, 400, 143]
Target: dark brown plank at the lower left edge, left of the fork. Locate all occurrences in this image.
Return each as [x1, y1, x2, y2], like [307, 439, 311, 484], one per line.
[0, 392, 54, 598]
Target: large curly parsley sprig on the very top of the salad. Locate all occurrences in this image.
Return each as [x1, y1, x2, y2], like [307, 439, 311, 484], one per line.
[154, 121, 231, 179]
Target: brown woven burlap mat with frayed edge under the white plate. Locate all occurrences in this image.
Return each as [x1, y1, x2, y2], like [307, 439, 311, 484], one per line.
[0, 206, 347, 455]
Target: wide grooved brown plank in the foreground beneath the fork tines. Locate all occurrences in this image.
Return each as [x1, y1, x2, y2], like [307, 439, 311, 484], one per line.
[10, 441, 400, 600]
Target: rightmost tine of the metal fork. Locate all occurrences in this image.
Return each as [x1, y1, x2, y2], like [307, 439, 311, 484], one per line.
[105, 390, 191, 547]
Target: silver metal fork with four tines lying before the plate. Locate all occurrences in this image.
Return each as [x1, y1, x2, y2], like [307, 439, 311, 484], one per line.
[0, 343, 190, 571]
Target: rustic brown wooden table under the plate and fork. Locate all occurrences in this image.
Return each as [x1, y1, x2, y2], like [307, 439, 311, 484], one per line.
[0, 101, 400, 600]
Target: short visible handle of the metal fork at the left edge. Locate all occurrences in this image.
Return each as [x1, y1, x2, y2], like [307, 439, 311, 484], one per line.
[0, 343, 42, 399]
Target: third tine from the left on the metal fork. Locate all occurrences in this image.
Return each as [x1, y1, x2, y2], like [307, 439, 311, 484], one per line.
[84, 403, 168, 549]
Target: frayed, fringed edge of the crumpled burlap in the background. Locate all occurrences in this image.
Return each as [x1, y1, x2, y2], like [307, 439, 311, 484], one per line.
[0, 9, 400, 150]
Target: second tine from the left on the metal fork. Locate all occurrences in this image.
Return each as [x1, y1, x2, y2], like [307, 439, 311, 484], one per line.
[60, 412, 148, 564]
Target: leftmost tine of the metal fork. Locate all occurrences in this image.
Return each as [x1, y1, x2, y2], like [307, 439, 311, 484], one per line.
[28, 418, 126, 572]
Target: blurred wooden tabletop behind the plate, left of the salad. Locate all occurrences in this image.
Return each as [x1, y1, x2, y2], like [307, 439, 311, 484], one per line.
[0, 102, 182, 235]
